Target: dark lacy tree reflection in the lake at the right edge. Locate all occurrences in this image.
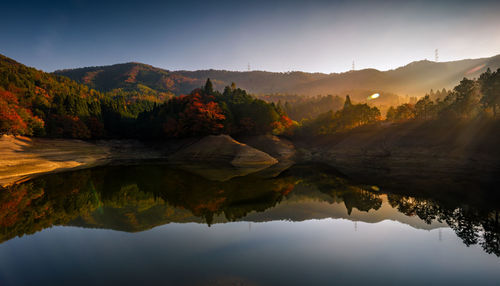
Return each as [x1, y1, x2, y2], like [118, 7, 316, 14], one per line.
[388, 194, 500, 256]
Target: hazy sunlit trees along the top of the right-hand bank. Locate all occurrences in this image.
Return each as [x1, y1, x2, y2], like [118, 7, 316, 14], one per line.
[293, 69, 500, 136]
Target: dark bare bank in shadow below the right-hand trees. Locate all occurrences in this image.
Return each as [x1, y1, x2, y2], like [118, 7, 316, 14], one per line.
[293, 118, 500, 194]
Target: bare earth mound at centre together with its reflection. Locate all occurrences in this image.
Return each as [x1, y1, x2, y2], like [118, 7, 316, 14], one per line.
[169, 135, 278, 181]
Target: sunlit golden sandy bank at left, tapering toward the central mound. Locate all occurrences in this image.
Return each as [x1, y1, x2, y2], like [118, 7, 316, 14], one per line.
[0, 135, 172, 186]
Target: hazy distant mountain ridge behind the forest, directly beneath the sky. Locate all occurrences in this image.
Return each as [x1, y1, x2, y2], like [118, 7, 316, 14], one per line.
[55, 55, 500, 96]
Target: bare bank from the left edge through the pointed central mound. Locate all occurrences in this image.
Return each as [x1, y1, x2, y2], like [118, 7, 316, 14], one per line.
[0, 135, 286, 186]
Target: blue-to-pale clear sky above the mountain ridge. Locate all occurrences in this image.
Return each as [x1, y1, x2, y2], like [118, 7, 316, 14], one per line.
[0, 0, 500, 73]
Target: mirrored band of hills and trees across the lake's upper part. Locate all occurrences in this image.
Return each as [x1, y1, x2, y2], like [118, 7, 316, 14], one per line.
[0, 165, 500, 256]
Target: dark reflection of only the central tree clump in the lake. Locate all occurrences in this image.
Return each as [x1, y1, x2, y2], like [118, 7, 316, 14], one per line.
[122, 167, 290, 224]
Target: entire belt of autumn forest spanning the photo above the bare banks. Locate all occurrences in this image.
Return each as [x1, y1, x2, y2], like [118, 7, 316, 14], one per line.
[0, 55, 500, 139]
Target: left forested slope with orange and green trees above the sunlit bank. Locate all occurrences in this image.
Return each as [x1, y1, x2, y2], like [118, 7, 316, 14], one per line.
[0, 55, 166, 138]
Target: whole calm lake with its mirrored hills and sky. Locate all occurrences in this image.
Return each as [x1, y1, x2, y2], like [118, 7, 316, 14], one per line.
[0, 164, 500, 285]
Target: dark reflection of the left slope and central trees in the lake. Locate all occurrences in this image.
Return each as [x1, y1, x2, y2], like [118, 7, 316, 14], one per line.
[0, 166, 293, 237]
